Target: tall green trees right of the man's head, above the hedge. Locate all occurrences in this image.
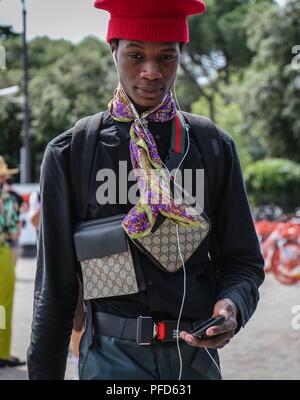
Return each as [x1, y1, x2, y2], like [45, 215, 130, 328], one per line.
[186, 0, 300, 169]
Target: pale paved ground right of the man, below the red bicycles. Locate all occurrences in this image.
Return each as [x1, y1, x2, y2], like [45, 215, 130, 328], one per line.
[220, 274, 300, 380]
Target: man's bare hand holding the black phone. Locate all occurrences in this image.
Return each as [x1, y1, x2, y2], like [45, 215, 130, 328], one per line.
[180, 299, 238, 349]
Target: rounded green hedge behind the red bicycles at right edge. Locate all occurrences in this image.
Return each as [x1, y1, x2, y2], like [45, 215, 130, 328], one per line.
[244, 158, 300, 210]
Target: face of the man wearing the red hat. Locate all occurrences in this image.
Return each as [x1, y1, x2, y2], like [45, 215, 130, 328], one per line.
[111, 40, 180, 112]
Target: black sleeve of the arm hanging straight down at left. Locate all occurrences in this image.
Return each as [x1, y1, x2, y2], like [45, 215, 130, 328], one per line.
[27, 139, 78, 380]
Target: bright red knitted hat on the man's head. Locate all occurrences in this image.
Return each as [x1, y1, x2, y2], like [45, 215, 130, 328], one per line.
[95, 0, 205, 43]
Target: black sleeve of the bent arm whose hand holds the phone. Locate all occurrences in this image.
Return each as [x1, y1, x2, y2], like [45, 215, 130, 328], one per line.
[211, 129, 264, 332]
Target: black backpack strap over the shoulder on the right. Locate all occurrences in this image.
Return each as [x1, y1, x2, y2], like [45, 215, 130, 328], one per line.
[183, 112, 224, 214]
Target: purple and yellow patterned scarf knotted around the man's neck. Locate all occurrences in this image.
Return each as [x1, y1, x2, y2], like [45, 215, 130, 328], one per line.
[108, 83, 202, 239]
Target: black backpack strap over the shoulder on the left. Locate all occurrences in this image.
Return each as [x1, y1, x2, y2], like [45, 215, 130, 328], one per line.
[70, 111, 105, 221]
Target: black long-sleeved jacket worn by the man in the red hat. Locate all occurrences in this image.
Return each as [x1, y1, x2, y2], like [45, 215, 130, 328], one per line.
[28, 114, 264, 379]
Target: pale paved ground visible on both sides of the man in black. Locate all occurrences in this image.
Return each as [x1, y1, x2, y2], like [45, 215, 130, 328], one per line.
[0, 259, 300, 380]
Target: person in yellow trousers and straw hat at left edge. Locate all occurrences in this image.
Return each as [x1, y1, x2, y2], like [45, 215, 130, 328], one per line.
[0, 156, 25, 368]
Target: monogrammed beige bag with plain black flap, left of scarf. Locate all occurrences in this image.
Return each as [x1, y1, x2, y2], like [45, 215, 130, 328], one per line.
[74, 215, 145, 300]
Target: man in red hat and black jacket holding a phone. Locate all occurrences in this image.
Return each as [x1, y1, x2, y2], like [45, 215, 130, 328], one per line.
[28, 0, 264, 379]
